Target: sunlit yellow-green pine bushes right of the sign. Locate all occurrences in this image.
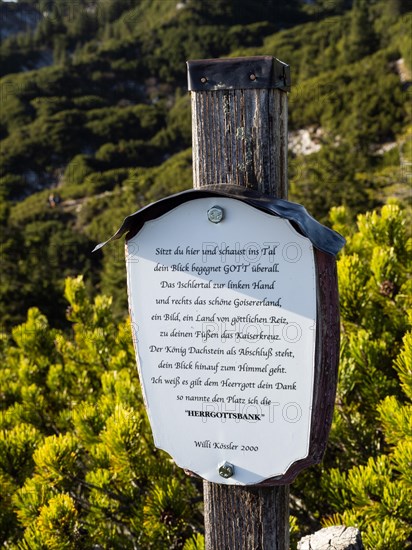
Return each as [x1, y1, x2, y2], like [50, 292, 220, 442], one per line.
[322, 204, 412, 550]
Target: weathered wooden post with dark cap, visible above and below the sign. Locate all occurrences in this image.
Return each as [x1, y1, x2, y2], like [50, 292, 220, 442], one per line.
[188, 57, 290, 550]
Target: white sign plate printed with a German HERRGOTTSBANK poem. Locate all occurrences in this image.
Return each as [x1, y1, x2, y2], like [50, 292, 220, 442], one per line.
[126, 197, 316, 484]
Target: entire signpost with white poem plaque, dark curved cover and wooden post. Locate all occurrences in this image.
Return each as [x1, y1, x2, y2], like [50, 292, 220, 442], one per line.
[96, 57, 344, 550]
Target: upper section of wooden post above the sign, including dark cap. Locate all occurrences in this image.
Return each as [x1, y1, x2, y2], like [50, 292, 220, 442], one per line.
[187, 56, 290, 199]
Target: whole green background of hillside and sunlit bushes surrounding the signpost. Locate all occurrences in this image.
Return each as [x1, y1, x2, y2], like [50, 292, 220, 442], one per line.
[0, 0, 412, 550]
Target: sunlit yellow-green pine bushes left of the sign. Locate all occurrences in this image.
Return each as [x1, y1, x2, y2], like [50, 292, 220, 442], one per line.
[0, 277, 201, 550]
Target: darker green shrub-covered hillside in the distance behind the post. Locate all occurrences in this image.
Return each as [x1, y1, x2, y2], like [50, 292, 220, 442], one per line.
[0, 0, 411, 326]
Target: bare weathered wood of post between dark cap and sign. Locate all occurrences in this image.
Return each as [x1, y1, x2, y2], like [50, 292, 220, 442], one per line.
[192, 89, 288, 199]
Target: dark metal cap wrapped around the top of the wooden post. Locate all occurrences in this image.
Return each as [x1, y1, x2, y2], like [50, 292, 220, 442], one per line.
[187, 55, 291, 92]
